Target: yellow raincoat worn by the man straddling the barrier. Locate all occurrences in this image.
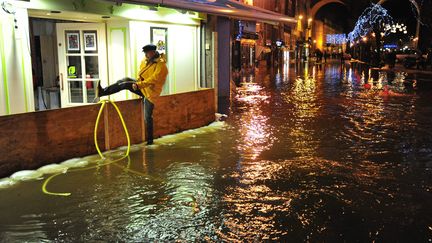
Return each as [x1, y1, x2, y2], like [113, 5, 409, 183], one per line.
[137, 54, 168, 103]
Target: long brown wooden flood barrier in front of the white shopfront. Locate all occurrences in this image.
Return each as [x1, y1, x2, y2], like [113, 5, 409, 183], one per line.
[0, 89, 215, 178]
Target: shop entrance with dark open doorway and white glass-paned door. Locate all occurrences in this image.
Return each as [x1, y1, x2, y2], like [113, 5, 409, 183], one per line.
[29, 10, 108, 111]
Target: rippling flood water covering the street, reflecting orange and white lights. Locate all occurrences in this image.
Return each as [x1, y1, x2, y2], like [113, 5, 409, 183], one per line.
[0, 64, 432, 242]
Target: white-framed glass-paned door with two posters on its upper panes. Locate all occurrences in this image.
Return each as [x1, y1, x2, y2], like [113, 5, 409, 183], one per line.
[57, 23, 107, 107]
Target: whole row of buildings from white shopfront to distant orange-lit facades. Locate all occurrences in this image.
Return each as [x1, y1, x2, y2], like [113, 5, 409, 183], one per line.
[0, 0, 344, 115]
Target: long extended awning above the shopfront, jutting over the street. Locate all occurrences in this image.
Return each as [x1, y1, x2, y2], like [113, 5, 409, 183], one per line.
[111, 0, 297, 24]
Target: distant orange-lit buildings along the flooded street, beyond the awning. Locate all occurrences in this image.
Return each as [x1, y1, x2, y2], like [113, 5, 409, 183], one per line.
[233, 0, 346, 68]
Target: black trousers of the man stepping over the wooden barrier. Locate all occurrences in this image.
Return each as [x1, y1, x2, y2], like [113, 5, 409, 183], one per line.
[99, 78, 154, 143]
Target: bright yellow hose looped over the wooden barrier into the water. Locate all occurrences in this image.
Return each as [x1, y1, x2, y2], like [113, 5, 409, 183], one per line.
[42, 100, 130, 197]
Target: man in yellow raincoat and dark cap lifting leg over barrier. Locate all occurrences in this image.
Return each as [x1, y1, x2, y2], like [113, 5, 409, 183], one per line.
[96, 45, 168, 145]
